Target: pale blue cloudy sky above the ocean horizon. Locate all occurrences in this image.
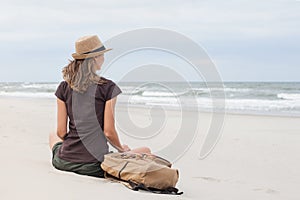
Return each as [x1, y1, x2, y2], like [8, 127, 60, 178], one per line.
[0, 0, 300, 82]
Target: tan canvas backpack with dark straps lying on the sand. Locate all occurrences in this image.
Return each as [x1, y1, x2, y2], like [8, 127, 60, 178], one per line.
[101, 152, 183, 195]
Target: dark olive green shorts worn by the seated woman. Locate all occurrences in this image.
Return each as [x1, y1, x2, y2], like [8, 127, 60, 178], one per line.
[52, 142, 104, 178]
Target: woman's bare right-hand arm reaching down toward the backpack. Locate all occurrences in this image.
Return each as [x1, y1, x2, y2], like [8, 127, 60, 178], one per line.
[103, 97, 130, 152]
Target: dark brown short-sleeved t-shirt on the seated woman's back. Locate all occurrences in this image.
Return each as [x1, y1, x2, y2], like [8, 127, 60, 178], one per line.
[55, 77, 122, 163]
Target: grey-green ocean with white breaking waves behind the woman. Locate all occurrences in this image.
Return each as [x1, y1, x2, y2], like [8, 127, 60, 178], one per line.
[0, 82, 300, 116]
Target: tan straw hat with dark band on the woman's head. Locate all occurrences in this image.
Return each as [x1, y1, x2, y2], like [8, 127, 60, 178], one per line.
[72, 35, 112, 59]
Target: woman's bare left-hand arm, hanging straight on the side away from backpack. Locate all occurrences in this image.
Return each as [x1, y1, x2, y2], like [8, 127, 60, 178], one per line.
[56, 98, 68, 140]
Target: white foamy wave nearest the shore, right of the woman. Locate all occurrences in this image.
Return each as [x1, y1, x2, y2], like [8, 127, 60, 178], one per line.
[118, 96, 300, 114]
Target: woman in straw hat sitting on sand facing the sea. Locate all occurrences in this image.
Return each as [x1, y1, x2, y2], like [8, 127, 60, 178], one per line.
[49, 35, 151, 177]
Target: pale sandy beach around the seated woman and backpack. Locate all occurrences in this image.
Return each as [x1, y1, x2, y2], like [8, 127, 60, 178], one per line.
[0, 97, 300, 200]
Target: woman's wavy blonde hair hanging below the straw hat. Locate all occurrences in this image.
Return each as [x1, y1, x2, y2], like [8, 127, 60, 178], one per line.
[62, 58, 107, 93]
